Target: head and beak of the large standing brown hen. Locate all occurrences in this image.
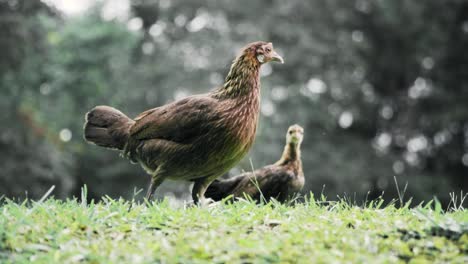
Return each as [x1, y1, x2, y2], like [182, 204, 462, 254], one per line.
[242, 41, 284, 65]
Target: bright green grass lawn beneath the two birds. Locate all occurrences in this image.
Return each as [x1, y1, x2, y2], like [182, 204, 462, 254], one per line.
[0, 191, 468, 263]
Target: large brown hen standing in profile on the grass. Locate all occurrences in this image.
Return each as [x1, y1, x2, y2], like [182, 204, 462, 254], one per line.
[84, 41, 283, 203]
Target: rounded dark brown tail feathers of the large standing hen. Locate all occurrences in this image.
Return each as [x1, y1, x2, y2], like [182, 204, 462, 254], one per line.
[84, 105, 135, 150]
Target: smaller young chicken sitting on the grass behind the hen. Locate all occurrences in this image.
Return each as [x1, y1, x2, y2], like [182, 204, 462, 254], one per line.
[205, 125, 304, 202]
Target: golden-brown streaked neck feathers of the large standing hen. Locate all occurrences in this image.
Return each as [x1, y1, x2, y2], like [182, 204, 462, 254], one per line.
[213, 52, 260, 100]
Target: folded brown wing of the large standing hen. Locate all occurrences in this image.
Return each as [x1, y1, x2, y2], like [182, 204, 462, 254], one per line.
[130, 95, 218, 144]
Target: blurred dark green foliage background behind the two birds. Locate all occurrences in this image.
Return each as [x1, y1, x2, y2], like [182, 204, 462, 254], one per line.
[0, 0, 468, 204]
